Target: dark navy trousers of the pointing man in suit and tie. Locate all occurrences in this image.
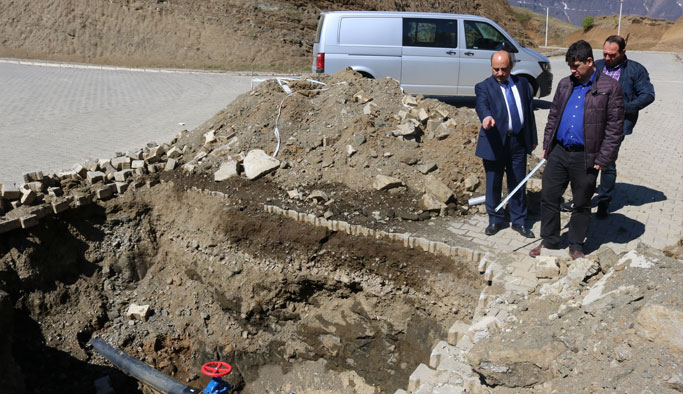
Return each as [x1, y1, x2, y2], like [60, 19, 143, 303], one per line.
[484, 136, 527, 226]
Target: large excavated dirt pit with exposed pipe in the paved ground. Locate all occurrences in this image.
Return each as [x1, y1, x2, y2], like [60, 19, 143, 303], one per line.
[0, 182, 484, 393]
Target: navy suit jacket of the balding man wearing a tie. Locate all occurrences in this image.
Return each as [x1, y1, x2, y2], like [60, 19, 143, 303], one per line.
[474, 75, 538, 160]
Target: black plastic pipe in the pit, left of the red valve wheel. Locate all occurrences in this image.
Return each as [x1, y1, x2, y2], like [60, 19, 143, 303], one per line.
[90, 338, 201, 394]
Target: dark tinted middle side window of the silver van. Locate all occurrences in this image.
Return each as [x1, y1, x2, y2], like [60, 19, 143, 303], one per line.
[403, 18, 458, 48]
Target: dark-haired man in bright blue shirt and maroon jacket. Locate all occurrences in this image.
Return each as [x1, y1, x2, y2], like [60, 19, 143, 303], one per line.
[529, 40, 624, 259]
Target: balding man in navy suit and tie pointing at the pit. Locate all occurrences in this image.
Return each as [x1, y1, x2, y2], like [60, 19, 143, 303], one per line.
[474, 51, 538, 238]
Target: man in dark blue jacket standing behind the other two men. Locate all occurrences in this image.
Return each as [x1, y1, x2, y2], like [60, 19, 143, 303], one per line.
[562, 35, 655, 219]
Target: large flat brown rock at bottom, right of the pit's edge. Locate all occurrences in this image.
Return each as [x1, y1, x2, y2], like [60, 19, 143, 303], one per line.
[468, 334, 565, 388]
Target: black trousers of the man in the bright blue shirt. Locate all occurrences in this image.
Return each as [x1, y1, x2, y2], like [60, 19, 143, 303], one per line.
[541, 145, 598, 251]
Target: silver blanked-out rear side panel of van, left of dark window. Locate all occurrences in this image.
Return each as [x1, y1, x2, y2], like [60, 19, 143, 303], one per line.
[339, 17, 401, 46]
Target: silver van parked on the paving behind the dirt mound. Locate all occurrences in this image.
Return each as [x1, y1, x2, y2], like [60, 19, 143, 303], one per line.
[313, 11, 553, 97]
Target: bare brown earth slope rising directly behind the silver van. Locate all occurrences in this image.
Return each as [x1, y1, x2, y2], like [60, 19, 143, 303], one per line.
[0, 0, 531, 71]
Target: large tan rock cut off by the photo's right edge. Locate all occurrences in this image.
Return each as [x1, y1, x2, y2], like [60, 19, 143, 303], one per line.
[636, 305, 683, 353]
